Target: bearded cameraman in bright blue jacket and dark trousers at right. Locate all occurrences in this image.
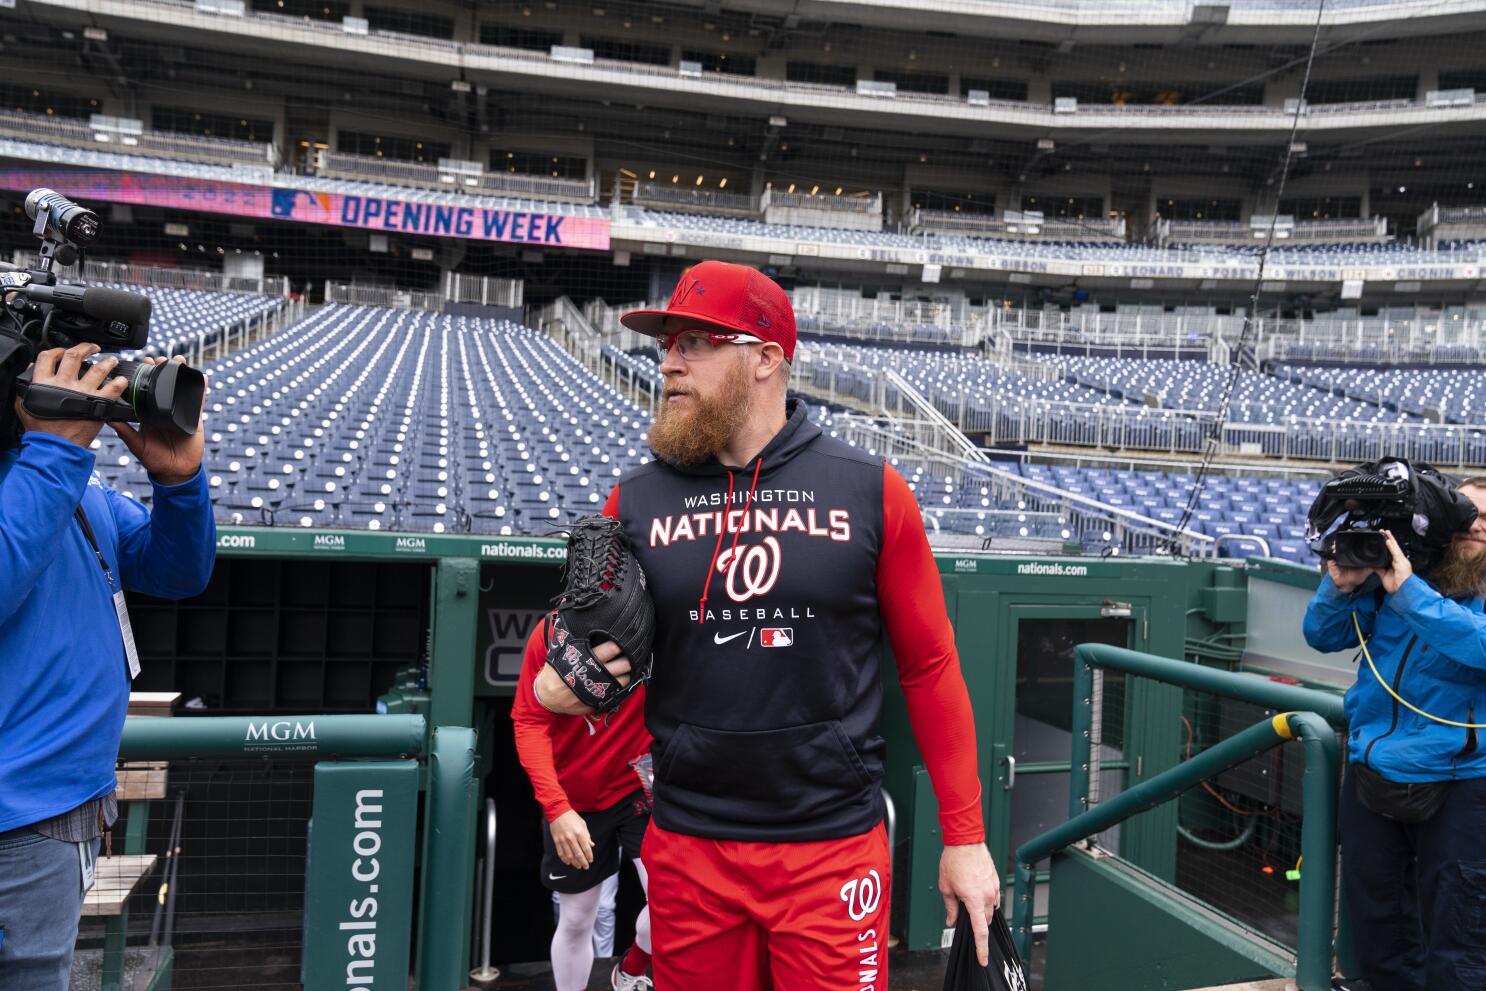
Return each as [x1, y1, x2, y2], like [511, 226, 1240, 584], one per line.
[1305, 487, 1486, 991]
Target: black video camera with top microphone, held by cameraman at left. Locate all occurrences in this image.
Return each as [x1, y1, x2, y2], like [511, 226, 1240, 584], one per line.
[0, 189, 205, 434]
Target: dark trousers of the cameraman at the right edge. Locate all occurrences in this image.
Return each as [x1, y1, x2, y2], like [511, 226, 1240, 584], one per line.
[1337, 768, 1486, 991]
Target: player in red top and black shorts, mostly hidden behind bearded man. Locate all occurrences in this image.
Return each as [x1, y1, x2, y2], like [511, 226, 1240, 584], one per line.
[511, 620, 652, 991]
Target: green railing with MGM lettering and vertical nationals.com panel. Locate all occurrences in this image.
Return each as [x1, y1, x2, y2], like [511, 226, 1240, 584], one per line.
[115, 715, 477, 991]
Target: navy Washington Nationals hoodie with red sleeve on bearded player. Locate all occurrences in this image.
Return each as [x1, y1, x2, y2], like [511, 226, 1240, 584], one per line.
[606, 403, 981, 842]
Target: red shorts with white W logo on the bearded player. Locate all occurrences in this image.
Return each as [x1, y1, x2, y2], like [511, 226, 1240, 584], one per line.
[642, 820, 890, 991]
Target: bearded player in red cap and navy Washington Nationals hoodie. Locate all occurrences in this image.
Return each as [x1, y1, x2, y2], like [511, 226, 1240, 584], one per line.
[535, 261, 1000, 991]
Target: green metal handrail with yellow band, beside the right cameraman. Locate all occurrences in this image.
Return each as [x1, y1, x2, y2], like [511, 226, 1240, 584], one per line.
[1012, 643, 1346, 991]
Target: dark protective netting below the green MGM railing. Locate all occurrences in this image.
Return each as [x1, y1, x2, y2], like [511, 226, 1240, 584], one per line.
[71, 759, 314, 991]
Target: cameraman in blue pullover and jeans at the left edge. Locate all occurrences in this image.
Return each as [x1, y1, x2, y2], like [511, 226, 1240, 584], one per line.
[0, 345, 217, 991]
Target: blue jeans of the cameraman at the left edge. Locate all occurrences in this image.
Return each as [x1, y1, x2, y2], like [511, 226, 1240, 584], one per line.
[0, 828, 98, 991]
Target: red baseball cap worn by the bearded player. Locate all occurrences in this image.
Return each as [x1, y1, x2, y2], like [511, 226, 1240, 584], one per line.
[620, 261, 795, 361]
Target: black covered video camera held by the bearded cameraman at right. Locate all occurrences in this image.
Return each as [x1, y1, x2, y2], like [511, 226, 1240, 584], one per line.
[1306, 458, 1476, 572]
